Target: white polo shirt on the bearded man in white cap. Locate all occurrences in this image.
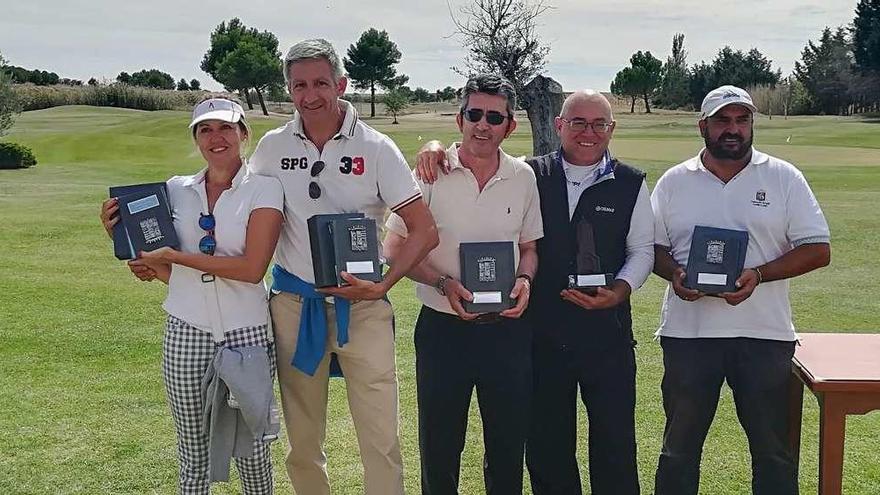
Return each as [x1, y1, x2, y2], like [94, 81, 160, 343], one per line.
[651, 149, 830, 341]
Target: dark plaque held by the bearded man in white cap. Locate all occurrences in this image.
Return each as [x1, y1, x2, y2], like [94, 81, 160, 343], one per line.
[684, 225, 749, 294]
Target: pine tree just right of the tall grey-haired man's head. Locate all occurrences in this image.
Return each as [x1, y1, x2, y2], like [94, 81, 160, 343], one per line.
[343, 28, 409, 117]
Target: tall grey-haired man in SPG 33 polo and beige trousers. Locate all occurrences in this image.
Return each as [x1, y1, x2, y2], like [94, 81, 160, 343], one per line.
[250, 40, 437, 495]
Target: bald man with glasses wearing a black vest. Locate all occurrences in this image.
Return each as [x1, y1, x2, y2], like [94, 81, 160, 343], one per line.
[418, 90, 654, 495]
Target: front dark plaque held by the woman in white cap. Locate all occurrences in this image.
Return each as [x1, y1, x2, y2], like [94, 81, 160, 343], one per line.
[118, 189, 180, 259]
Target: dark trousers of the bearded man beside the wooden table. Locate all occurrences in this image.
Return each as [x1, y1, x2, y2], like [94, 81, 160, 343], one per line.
[655, 337, 798, 495]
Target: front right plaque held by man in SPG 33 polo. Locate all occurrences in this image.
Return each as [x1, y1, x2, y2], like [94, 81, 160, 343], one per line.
[330, 218, 382, 286]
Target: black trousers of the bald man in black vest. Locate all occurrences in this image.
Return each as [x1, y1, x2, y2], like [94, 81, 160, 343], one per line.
[526, 341, 639, 495]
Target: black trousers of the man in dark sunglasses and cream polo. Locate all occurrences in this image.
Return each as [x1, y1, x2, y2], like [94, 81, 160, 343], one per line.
[415, 306, 532, 495]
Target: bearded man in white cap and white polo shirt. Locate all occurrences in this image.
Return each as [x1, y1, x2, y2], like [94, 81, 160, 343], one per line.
[651, 86, 831, 495]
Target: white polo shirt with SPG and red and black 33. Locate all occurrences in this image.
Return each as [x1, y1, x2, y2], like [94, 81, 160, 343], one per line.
[248, 100, 421, 283]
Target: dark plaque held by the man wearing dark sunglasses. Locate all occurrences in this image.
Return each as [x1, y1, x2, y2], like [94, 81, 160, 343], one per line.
[458, 241, 516, 313]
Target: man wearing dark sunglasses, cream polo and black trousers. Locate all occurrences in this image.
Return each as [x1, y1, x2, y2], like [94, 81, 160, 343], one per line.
[385, 74, 543, 495]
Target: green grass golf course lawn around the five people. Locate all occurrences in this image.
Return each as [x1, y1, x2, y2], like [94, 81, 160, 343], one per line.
[0, 107, 880, 495]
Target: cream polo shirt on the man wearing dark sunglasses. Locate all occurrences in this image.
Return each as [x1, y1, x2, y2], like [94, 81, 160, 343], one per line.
[386, 143, 544, 314]
